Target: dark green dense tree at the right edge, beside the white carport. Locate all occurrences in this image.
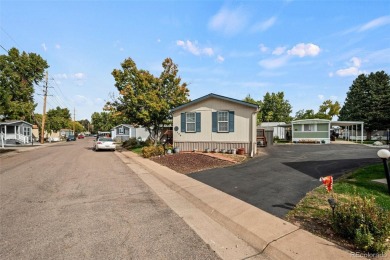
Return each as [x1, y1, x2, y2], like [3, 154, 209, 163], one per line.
[339, 71, 390, 138]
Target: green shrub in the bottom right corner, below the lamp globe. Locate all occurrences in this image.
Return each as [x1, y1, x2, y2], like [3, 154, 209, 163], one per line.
[332, 197, 390, 253]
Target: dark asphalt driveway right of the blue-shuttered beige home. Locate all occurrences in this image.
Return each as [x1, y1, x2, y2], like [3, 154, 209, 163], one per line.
[189, 144, 381, 218]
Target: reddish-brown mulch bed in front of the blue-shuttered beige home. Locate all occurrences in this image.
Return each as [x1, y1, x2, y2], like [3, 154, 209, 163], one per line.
[150, 153, 235, 174]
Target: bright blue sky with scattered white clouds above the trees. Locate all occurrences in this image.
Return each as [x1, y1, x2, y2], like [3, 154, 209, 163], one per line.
[0, 0, 390, 120]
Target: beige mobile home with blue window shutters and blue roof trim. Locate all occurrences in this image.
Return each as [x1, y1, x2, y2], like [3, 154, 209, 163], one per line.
[172, 94, 259, 156]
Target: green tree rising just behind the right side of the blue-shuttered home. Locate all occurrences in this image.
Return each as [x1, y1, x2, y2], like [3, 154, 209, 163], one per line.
[260, 92, 292, 122]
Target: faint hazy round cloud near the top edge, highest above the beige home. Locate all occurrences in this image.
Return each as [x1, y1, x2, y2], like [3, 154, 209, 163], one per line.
[209, 8, 248, 35]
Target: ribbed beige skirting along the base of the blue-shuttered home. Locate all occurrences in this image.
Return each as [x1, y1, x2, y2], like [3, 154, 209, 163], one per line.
[173, 142, 257, 154]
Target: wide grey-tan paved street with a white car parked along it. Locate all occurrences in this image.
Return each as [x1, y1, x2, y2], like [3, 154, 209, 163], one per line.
[0, 139, 218, 259]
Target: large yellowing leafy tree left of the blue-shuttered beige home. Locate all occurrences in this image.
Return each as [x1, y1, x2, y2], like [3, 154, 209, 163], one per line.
[107, 58, 189, 144]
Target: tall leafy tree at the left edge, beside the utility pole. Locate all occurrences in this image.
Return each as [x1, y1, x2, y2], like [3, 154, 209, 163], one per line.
[0, 48, 49, 122]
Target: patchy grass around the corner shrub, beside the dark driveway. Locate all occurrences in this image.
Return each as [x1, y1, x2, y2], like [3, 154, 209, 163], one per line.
[286, 163, 390, 253]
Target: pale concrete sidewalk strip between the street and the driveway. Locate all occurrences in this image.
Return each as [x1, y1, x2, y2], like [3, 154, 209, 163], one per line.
[122, 152, 352, 260]
